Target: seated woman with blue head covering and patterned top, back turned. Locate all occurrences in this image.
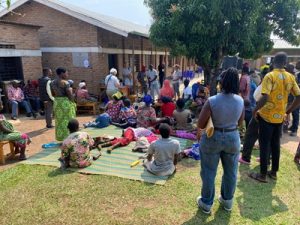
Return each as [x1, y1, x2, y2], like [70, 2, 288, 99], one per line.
[137, 95, 156, 128]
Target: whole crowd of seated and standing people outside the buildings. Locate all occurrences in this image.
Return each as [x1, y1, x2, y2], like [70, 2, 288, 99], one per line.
[0, 52, 300, 214]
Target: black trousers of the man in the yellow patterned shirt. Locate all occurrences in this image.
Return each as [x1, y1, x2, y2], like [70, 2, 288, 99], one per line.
[258, 117, 282, 175]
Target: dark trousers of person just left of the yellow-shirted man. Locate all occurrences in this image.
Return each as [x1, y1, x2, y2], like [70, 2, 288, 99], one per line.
[242, 118, 259, 162]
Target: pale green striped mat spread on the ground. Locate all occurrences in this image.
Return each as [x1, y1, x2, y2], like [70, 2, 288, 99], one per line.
[23, 126, 192, 185]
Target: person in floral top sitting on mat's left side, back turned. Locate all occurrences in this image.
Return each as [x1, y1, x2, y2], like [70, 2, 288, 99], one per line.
[59, 119, 94, 168]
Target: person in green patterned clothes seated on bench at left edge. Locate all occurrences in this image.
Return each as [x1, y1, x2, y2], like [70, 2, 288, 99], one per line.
[0, 102, 31, 160]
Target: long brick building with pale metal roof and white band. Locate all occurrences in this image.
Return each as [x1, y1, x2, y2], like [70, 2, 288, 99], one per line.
[0, 0, 192, 93]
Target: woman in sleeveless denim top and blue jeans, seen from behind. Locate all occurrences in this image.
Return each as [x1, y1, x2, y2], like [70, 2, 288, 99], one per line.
[197, 68, 245, 214]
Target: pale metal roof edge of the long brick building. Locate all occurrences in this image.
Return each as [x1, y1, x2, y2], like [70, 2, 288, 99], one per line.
[0, 0, 149, 37]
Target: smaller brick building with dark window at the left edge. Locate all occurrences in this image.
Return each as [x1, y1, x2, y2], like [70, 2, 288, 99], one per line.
[0, 20, 42, 81]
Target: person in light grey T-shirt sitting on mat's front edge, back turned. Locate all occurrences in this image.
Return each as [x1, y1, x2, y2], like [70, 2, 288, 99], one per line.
[144, 124, 181, 176]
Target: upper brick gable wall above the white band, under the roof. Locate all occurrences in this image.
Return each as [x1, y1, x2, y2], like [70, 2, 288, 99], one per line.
[2, 1, 97, 47]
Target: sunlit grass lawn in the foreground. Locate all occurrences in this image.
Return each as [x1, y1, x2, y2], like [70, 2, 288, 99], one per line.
[0, 150, 300, 225]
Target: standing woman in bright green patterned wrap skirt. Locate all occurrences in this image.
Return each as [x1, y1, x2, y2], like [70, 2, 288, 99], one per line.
[51, 68, 76, 141]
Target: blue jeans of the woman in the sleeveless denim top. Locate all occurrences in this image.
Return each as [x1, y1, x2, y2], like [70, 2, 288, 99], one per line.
[200, 131, 241, 210]
